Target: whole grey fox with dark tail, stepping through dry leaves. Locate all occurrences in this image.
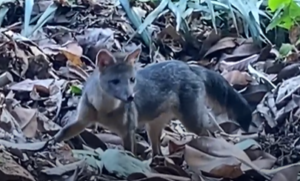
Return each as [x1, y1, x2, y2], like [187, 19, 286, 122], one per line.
[54, 47, 252, 155]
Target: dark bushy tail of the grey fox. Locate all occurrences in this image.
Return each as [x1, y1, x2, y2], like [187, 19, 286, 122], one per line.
[190, 66, 252, 131]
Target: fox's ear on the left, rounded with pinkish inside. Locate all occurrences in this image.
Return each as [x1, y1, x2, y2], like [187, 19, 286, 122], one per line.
[96, 49, 116, 70]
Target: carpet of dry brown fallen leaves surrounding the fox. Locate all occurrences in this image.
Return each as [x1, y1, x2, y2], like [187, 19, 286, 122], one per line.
[0, 0, 300, 181]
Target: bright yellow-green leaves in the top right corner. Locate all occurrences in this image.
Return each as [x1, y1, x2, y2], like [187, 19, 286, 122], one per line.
[266, 0, 300, 31]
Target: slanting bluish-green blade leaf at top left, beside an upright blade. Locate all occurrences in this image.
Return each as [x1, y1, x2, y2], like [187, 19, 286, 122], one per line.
[29, 2, 58, 36]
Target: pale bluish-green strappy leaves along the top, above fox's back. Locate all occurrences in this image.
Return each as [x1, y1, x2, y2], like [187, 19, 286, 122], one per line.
[130, 0, 269, 42]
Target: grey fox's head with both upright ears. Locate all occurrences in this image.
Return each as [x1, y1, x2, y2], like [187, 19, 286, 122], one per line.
[96, 46, 141, 102]
